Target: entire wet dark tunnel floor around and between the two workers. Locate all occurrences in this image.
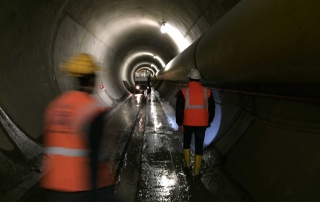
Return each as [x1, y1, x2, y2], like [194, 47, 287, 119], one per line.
[18, 90, 252, 202]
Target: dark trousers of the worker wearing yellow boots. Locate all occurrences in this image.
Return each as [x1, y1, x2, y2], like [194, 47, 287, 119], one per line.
[183, 126, 207, 156]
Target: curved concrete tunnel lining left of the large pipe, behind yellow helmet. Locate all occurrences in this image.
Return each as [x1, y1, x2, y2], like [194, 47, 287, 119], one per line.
[0, 0, 239, 139]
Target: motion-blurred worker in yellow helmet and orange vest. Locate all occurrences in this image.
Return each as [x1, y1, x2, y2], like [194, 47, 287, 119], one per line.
[40, 53, 116, 202]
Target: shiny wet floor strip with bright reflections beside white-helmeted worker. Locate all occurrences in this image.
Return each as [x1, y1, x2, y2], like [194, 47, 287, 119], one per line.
[136, 91, 213, 202]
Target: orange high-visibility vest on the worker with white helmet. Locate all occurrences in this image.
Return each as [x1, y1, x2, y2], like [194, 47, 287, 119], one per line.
[182, 81, 211, 126]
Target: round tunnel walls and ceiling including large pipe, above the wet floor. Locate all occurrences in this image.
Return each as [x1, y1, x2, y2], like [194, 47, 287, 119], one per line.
[0, 0, 320, 202]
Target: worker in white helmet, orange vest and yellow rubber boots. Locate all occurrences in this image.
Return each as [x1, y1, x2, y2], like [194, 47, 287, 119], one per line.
[176, 69, 215, 176]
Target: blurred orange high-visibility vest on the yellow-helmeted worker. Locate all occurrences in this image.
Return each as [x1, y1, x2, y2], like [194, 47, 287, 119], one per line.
[40, 91, 115, 192]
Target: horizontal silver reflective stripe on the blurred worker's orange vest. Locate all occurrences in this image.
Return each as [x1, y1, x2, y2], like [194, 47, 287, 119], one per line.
[44, 147, 90, 157]
